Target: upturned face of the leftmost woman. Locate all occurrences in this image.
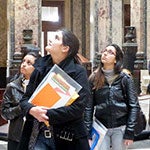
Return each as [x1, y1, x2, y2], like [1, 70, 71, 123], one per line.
[20, 55, 36, 79]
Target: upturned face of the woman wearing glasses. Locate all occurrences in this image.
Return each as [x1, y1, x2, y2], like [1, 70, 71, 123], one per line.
[101, 46, 116, 68]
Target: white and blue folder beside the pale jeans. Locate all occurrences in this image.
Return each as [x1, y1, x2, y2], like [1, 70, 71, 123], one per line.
[90, 119, 107, 150]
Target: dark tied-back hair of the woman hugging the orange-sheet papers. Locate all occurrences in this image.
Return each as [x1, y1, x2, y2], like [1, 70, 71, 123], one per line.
[59, 28, 80, 63]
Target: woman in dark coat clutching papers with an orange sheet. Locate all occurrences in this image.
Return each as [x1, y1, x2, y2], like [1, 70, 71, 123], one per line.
[17, 29, 89, 150]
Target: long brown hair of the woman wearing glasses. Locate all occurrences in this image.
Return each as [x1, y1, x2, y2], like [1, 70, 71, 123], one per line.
[89, 44, 123, 89]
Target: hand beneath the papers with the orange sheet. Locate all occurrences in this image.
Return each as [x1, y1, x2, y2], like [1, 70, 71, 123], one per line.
[29, 106, 49, 122]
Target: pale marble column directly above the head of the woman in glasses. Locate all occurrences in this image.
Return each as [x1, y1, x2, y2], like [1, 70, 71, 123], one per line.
[96, 0, 123, 50]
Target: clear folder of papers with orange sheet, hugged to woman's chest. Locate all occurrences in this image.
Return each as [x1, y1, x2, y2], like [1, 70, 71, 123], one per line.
[29, 64, 82, 108]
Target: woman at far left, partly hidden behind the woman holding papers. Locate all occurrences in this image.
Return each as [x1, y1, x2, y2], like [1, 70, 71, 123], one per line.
[2, 52, 38, 150]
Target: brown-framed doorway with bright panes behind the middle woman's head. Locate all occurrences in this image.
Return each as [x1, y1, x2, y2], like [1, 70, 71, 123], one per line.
[41, 0, 65, 56]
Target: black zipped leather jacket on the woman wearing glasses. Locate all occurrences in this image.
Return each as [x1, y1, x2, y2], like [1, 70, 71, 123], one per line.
[85, 73, 139, 139]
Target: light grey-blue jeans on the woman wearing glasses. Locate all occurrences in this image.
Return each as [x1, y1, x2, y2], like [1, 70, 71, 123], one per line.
[99, 126, 126, 150]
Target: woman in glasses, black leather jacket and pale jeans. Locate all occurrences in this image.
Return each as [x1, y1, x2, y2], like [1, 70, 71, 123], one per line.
[85, 44, 139, 150]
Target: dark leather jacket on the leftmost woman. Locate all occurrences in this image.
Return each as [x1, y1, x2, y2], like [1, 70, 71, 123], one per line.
[2, 77, 24, 142]
